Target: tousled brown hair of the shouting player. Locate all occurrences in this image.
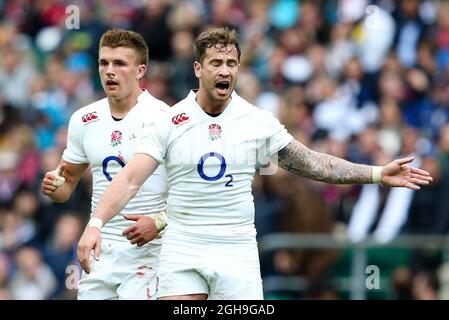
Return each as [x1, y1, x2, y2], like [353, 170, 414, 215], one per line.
[195, 27, 241, 63]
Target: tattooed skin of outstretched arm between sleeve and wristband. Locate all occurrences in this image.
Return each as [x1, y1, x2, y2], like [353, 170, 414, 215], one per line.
[278, 140, 372, 184]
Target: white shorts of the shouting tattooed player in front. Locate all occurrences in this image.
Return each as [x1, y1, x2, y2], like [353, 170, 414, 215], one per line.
[158, 234, 263, 300]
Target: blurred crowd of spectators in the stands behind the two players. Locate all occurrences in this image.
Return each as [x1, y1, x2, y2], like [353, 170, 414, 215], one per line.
[0, 0, 449, 299]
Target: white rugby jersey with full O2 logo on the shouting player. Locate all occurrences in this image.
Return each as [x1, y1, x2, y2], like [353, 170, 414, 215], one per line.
[136, 91, 293, 242]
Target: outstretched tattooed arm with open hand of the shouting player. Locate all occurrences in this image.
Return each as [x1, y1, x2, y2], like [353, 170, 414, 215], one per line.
[278, 140, 432, 190]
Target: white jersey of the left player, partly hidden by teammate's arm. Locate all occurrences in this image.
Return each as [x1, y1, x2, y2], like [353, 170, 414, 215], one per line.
[62, 91, 170, 241]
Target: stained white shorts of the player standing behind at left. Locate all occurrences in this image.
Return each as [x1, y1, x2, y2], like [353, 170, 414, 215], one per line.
[78, 239, 161, 300]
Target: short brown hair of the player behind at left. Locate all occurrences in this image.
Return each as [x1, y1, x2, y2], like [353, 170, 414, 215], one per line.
[99, 28, 148, 65]
